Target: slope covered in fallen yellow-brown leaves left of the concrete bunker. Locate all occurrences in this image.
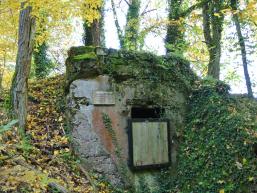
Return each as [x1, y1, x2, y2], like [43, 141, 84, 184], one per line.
[0, 76, 110, 193]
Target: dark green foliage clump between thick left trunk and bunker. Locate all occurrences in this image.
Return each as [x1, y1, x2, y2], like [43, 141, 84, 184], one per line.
[34, 42, 55, 79]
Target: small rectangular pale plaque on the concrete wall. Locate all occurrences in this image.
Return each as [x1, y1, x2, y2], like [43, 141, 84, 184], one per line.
[93, 91, 115, 105]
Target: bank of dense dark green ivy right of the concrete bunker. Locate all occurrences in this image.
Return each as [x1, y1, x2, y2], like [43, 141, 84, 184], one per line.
[165, 79, 257, 192]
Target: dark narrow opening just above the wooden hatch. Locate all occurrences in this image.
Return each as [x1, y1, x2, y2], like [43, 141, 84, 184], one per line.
[131, 107, 163, 119]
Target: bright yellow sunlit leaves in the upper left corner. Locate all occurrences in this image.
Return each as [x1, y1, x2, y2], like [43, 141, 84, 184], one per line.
[0, 0, 102, 77]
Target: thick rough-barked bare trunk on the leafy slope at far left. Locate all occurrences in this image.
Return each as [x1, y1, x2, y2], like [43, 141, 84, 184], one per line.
[11, 3, 35, 129]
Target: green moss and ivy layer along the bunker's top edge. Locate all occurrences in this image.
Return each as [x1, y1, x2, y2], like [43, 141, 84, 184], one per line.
[66, 47, 197, 95]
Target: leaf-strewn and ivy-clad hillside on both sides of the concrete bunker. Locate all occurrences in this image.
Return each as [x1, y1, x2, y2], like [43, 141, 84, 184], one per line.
[0, 76, 257, 193]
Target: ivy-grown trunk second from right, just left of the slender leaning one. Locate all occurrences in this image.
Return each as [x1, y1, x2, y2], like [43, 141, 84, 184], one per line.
[203, 0, 224, 79]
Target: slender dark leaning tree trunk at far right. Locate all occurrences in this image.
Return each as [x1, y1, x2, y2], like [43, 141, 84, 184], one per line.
[231, 0, 253, 97]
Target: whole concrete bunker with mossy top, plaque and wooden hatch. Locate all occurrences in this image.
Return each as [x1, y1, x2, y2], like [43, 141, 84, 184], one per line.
[66, 47, 196, 192]
